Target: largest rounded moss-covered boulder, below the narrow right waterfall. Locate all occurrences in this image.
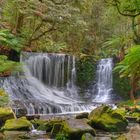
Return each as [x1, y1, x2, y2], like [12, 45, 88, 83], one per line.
[89, 106, 128, 132]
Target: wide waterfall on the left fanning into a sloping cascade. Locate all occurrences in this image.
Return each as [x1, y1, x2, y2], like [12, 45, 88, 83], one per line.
[0, 53, 93, 114]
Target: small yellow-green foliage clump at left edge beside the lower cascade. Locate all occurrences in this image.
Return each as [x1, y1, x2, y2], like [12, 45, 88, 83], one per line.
[0, 89, 9, 107]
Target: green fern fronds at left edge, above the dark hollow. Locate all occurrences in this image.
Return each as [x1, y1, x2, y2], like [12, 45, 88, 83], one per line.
[0, 29, 24, 52]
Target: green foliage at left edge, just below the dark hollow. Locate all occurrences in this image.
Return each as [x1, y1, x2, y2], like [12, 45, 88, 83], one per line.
[0, 55, 19, 74]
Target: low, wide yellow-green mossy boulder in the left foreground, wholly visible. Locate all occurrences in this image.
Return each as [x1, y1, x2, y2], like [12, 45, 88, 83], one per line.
[2, 117, 32, 131]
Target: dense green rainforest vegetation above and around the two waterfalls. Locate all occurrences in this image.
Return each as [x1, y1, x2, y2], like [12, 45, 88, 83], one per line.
[0, 0, 140, 98]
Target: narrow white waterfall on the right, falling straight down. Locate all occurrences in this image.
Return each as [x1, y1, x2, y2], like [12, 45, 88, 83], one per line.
[93, 58, 113, 103]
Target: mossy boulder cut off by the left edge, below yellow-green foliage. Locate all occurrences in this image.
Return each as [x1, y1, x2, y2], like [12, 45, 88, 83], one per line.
[0, 107, 15, 127]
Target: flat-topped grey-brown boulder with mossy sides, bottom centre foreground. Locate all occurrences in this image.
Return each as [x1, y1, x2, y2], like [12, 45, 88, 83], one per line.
[62, 119, 95, 140]
